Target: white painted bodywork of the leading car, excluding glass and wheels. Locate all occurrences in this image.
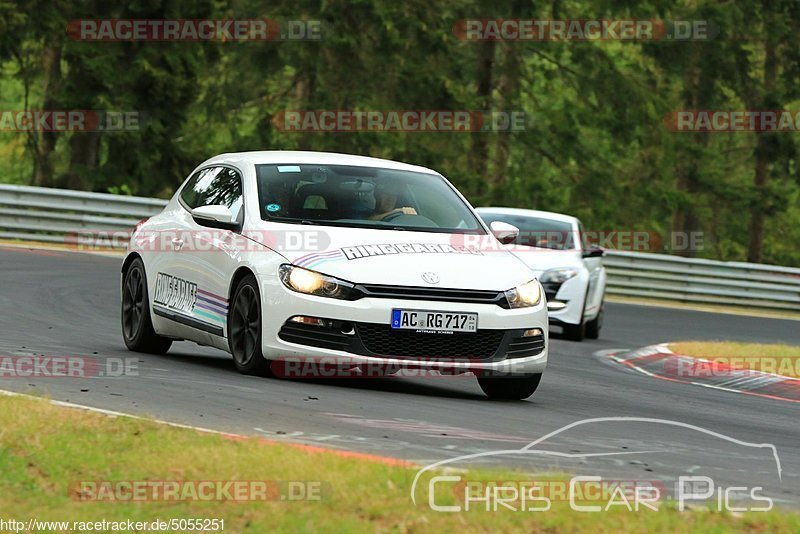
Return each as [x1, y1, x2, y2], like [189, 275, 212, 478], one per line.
[126, 151, 549, 375]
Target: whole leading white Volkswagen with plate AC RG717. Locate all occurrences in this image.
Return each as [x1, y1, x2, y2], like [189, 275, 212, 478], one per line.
[122, 151, 548, 399]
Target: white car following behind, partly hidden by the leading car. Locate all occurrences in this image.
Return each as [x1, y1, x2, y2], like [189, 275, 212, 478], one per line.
[477, 208, 606, 341]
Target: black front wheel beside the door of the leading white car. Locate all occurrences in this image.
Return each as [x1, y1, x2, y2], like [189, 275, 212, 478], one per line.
[228, 275, 272, 376]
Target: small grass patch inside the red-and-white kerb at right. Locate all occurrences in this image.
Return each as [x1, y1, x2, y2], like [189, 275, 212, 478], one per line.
[669, 341, 800, 378]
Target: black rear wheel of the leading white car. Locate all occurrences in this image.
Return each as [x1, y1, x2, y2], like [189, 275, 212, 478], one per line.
[120, 258, 172, 354]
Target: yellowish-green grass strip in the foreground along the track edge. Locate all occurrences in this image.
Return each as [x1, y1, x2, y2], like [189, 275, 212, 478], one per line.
[0, 397, 800, 533]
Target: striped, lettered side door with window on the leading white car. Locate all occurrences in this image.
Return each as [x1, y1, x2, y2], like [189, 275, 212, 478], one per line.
[153, 165, 244, 348]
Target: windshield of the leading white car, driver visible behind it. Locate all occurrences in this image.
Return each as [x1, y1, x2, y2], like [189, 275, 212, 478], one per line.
[256, 164, 485, 233]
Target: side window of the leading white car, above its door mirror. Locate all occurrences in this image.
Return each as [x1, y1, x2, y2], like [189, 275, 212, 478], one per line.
[181, 167, 243, 220]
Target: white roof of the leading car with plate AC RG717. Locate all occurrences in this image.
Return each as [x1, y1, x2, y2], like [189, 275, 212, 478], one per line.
[198, 150, 439, 176]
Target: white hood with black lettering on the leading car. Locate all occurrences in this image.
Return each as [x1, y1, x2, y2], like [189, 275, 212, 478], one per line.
[249, 223, 534, 291]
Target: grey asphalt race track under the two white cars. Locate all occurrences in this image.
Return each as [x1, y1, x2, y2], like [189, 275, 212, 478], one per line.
[0, 248, 800, 508]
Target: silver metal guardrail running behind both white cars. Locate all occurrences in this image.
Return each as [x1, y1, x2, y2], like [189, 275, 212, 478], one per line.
[0, 184, 800, 311]
